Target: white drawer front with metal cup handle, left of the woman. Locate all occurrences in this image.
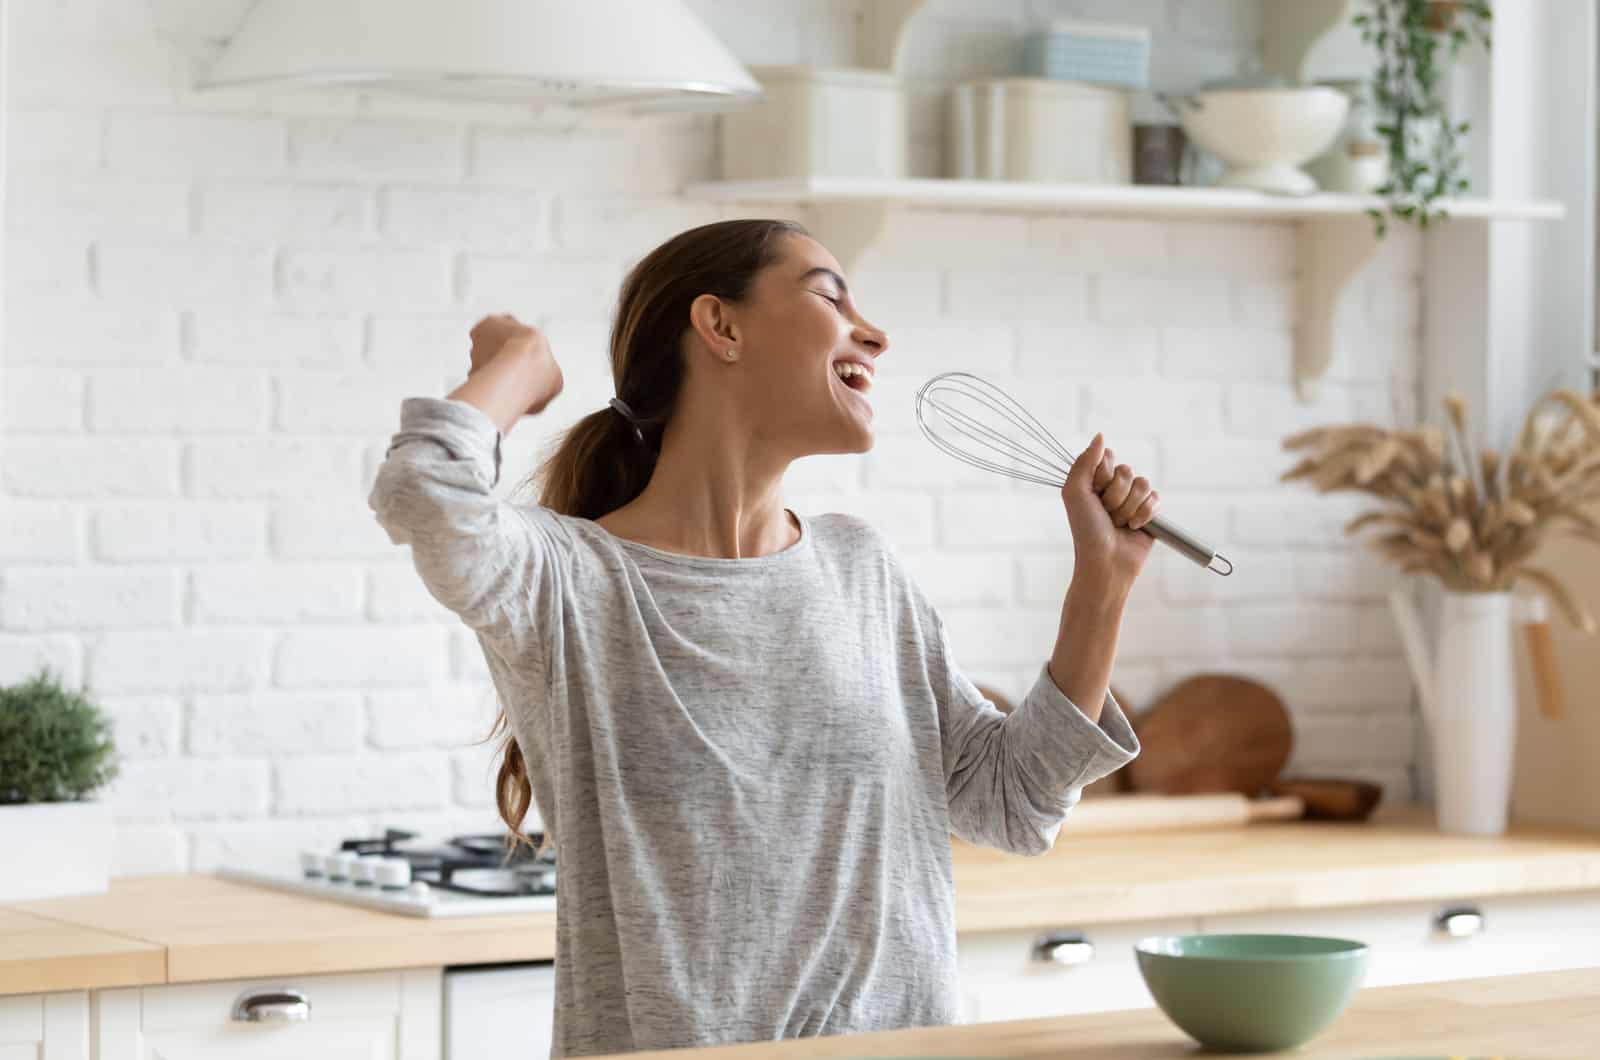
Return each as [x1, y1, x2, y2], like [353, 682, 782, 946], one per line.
[94, 969, 443, 1060]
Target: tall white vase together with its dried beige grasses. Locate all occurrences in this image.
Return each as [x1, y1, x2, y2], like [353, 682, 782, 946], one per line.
[1283, 391, 1600, 834]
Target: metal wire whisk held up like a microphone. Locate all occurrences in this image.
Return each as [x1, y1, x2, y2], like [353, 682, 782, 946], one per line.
[917, 371, 1234, 576]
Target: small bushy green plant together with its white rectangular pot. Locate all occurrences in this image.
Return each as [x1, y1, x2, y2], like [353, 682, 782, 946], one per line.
[0, 668, 117, 901]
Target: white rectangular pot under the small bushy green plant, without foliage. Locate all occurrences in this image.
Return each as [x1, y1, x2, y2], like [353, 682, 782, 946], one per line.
[0, 802, 112, 901]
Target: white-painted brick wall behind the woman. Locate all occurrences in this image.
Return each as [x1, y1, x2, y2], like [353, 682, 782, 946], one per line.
[0, 0, 1419, 873]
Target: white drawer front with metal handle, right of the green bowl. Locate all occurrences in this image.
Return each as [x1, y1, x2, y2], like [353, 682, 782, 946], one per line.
[1200, 893, 1600, 986]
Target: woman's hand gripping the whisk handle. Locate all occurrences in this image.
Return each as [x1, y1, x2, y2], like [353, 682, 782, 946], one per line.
[1061, 434, 1162, 594]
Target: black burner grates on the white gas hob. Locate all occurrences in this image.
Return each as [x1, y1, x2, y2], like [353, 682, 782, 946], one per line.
[339, 828, 555, 898]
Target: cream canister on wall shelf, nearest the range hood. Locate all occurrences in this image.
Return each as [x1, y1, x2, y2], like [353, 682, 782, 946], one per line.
[722, 66, 906, 181]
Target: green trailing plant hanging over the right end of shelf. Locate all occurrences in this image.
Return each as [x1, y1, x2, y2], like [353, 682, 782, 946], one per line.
[1352, 0, 1490, 239]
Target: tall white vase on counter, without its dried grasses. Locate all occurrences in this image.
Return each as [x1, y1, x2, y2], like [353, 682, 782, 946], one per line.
[1389, 591, 1517, 836]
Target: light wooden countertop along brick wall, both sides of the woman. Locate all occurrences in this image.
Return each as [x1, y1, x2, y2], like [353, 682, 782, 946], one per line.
[9, 809, 1600, 994]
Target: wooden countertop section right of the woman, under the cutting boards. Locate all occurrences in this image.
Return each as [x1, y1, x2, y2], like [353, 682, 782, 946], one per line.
[955, 805, 1600, 932]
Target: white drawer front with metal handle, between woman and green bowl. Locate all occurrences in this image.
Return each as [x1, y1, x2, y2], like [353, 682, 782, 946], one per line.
[955, 919, 1197, 1023]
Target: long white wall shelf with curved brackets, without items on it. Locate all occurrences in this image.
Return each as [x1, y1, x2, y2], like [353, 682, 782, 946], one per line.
[683, 178, 1566, 400]
